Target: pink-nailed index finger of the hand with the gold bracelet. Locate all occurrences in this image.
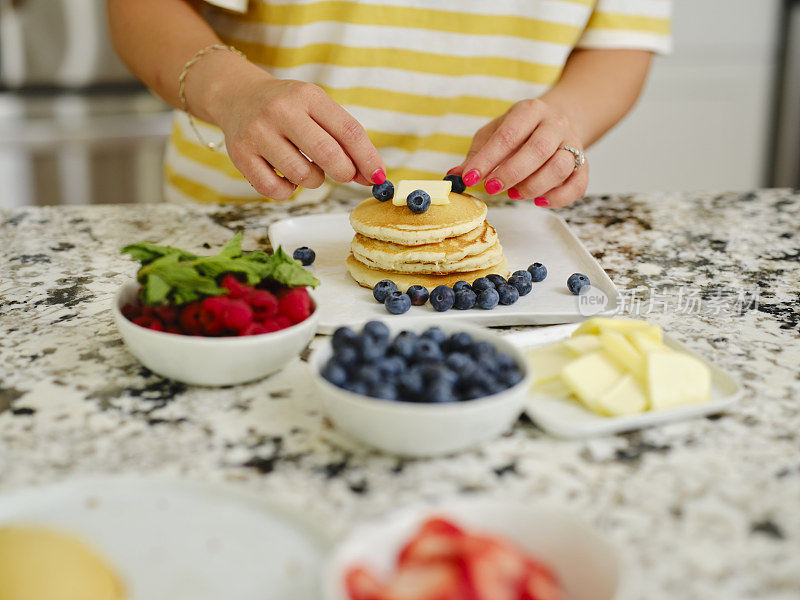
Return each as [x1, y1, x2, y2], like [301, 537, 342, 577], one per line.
[309, 98, 386, 184]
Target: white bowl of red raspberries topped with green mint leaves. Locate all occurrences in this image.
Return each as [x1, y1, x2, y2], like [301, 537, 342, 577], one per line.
[112, 234, 318, 386]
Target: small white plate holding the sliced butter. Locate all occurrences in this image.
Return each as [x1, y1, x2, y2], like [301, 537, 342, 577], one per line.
[508, 323, 743, 438]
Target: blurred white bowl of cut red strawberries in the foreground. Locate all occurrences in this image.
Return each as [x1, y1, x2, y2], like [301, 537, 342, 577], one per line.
[322, 499, 621, 600]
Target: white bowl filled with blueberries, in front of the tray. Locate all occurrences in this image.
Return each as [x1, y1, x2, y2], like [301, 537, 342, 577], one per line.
[311, 319, 531, 456]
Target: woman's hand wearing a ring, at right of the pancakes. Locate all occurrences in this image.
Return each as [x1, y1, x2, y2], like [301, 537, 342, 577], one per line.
[450, 99, 589, 207]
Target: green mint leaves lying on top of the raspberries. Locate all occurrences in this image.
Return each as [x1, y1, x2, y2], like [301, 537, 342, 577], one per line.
[121, 232, 319, 306]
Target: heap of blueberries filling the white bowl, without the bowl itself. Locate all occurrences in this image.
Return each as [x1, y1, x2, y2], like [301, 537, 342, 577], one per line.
[321, 324, 523, 403]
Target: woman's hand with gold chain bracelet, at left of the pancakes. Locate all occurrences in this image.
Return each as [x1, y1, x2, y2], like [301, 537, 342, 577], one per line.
[191, 53, 386, 200]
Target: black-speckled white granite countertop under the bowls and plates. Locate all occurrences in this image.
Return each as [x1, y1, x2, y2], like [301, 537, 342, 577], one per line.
[0, 190, 800, 600]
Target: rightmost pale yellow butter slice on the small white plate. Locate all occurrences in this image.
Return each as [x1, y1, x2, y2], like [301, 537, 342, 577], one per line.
[647, 352, 711, 410]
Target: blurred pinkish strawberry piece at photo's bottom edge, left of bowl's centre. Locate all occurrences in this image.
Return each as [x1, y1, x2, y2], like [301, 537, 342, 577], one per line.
[378, 563, 466, 600]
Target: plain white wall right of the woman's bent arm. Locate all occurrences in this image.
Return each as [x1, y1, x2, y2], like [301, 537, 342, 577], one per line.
[588, 0, 780, 193]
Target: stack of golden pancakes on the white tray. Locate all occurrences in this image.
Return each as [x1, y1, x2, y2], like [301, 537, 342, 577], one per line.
[347, 192, 508, 291]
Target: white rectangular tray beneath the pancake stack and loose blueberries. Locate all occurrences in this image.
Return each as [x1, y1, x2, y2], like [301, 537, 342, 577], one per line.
[269, 207, 619, 333]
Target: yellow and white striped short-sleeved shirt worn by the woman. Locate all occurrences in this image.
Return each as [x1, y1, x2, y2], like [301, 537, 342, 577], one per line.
[165, 0, 671, 202]
